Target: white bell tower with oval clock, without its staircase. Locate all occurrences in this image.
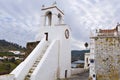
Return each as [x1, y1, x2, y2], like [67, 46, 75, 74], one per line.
[37, 5, 71, 78]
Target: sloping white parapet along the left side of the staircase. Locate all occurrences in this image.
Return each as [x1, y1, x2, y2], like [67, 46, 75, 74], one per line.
[10, 38, 47, 80]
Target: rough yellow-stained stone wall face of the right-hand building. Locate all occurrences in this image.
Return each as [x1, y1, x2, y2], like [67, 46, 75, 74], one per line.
[95, 37, 120, 80]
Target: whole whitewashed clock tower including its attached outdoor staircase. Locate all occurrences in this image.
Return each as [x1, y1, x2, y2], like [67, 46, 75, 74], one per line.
[0, 5, 71, 80]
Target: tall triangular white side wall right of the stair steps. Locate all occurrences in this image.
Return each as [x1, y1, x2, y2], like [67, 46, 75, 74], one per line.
[31, 40, 59, 80]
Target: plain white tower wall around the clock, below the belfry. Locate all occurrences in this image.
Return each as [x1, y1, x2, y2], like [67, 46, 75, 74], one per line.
[38, 25, 71, 78]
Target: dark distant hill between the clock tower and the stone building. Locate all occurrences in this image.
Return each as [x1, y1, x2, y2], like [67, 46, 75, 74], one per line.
[71, 50, 90, 61]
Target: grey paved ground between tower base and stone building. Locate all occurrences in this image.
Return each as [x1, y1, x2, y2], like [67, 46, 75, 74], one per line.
[68, 71, 89, 80]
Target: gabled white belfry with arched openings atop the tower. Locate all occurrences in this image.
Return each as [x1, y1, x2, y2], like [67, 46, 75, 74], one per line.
[41, 4, 64, 26]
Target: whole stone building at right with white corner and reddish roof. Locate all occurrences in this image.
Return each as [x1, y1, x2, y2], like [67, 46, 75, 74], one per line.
[89, 24, 120, 80]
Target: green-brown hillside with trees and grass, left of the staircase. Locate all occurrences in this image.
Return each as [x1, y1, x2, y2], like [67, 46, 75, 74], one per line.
[0, 40, 25, 75]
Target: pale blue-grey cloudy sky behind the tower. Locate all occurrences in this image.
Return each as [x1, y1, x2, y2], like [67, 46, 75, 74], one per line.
[0, 0, 120, 49]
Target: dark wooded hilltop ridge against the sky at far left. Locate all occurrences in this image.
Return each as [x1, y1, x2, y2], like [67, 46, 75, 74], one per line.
[0, 40, 25, 52]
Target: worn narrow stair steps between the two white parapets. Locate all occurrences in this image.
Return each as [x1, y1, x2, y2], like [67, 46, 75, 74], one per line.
[24, 43, 49, 80]
